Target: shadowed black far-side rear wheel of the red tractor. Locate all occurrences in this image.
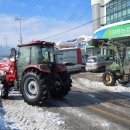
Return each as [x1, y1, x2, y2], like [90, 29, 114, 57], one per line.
[50, 72, 72, 98]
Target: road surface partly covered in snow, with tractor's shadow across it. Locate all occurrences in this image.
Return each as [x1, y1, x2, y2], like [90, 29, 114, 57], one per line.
[0, 73, 130, 130]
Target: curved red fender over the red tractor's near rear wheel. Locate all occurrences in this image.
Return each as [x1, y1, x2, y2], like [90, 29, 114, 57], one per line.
[22, 65, 50, 76]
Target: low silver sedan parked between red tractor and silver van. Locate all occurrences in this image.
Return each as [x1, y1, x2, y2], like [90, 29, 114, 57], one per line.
[63, 62, 85, 72]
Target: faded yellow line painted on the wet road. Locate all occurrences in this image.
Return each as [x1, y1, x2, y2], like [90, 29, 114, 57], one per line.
[87, 105, 130, 123]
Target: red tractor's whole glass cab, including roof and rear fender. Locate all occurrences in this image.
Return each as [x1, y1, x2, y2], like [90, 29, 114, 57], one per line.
[17, 41, 66, 79]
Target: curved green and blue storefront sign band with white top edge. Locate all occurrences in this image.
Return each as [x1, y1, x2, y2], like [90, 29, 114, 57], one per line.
[94, 20, 130, 54]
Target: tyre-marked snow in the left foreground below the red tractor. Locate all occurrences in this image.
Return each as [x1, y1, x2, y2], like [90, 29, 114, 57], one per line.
[0, 95, 65, 130]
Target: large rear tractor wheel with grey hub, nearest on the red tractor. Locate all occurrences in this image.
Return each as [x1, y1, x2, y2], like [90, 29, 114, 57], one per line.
[20, 72, 49, 105]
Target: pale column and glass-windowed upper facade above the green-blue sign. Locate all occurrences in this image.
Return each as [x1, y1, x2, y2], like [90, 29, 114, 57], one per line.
[91, 0, 130, 32]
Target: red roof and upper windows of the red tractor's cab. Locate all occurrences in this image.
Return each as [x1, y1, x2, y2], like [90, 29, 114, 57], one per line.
[18, 41, 54, 65]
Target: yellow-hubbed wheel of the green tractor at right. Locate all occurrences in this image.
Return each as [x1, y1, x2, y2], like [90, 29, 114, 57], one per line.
[102, 72, 116, 86]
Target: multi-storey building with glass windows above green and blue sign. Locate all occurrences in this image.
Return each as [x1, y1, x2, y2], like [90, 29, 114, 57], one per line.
[91, 0, 130, 54]
